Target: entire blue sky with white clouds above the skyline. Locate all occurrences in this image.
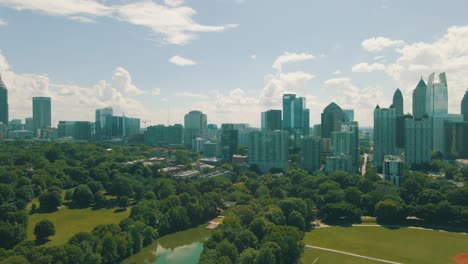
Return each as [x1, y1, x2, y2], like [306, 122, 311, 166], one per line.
[0, 0, 468, 127]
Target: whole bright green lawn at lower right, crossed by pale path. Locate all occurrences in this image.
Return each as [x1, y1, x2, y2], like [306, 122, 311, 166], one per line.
[303, 226, 468, 264]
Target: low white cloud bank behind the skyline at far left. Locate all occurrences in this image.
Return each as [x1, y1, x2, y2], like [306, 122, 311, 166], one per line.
[0, 53, 150, 124]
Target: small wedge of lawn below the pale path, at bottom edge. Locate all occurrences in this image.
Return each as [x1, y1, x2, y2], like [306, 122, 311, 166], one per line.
[302, 249, 381, 264]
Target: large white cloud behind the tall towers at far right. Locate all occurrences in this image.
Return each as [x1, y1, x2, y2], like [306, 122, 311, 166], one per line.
[376, 26, 468, 113]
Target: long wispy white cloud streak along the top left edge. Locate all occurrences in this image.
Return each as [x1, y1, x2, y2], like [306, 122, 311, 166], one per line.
[0, 0, 238, 45]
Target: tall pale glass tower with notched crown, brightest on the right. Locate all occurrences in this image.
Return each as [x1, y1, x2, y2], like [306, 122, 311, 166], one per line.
[426, 72, 448, 117]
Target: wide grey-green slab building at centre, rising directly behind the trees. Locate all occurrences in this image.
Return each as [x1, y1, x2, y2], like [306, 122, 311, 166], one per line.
[249, 130, 289, 172]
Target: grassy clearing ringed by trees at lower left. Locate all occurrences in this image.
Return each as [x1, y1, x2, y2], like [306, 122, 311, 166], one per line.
[27, 206, 130, 246]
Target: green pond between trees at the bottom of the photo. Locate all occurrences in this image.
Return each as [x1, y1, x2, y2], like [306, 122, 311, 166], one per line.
[122, 224, 211, 264]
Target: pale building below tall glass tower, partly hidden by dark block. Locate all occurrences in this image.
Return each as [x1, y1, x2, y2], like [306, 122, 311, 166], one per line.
[432, 114, 463, 155]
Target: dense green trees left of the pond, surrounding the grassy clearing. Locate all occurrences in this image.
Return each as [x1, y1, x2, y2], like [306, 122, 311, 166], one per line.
[0, 141, 225, 263]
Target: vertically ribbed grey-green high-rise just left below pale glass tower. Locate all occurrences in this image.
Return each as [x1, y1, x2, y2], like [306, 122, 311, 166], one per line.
[405, 117, 432, 167]
